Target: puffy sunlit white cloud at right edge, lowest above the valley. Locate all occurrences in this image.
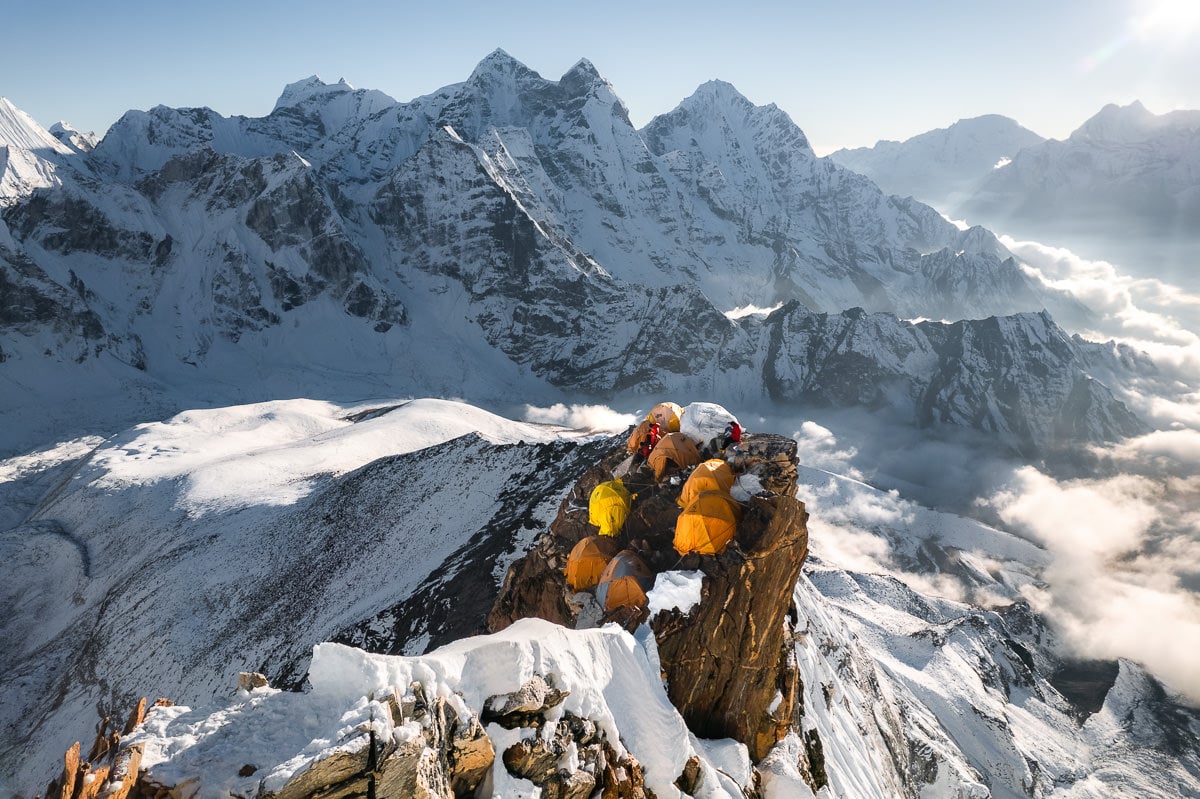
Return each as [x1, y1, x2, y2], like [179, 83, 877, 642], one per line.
[988, 463, 1200, 703]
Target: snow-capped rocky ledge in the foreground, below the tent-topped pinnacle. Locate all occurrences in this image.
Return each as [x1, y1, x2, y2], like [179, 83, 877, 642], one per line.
[110, 619, 696, 799]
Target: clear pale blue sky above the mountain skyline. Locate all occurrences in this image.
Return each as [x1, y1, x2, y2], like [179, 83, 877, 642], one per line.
[0, 0, 1200, 152]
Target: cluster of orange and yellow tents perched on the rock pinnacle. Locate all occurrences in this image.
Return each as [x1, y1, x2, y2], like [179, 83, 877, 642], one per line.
[565, 402, 742, 613]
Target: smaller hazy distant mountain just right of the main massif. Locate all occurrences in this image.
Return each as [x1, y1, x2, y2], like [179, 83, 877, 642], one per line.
[829, 114, 1045, 212]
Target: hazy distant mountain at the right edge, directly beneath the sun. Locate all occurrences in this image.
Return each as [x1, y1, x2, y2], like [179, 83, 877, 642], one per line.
[958, 102, 1200, 244]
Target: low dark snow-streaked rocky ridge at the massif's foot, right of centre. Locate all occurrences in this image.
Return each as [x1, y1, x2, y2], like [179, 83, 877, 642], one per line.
[762, 305, 1146, 451]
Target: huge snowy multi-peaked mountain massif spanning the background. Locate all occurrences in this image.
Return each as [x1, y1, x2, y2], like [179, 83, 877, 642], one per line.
[0, 52, 1121, 446]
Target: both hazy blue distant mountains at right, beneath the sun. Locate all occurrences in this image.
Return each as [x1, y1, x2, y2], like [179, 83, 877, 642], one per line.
[829, 102, 1200, 279]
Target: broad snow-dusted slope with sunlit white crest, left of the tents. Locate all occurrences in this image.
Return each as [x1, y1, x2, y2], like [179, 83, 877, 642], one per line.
[0, 400, 619, 789]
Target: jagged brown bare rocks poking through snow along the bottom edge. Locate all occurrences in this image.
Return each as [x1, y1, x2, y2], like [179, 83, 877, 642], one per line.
[71, 674, 654, 799]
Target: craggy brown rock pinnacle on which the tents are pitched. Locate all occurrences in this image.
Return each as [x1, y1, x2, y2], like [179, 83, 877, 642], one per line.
[488, 434, 808, 761]
